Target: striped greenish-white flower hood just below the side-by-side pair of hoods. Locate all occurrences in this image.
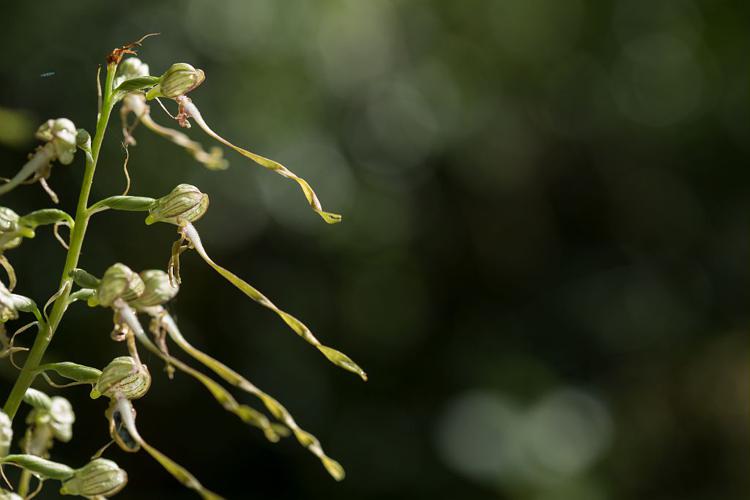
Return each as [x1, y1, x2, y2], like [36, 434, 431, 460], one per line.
[91, 356, 151, 399]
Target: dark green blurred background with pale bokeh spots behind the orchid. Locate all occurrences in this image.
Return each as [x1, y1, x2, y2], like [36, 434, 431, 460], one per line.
[0, 0, 750, 500]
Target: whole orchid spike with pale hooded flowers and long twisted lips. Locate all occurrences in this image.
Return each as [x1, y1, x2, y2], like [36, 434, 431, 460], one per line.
[0, 37, 367, 500]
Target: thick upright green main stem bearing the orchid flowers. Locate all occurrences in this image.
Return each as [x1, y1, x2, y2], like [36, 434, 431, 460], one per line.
[3, 64, 117, 419]
